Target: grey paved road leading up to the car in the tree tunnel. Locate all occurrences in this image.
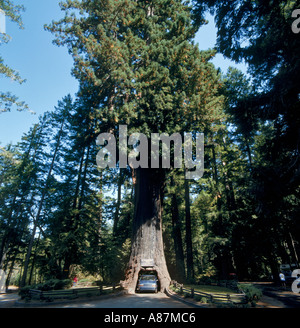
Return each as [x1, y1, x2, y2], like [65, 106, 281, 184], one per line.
[27, 293, 192, 309]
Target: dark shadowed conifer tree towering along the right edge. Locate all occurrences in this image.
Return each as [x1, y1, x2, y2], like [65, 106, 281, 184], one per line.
[193, 0, 300, 279]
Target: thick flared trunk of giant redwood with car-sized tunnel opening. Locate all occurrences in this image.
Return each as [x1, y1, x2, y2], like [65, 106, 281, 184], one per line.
[123, 168, 171, 294]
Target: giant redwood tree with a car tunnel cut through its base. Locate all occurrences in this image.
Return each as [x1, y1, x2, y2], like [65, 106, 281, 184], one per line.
[47, 0, 221, 292]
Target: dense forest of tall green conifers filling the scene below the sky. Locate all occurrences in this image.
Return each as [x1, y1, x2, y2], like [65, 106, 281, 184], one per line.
[0, 0, 300, 286]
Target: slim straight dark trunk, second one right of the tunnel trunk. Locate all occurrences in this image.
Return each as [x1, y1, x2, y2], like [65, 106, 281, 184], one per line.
[184, 180, 194, 281]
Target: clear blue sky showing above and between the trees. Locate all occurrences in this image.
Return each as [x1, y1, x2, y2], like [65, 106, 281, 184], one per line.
[0, 0, 245, 146]
